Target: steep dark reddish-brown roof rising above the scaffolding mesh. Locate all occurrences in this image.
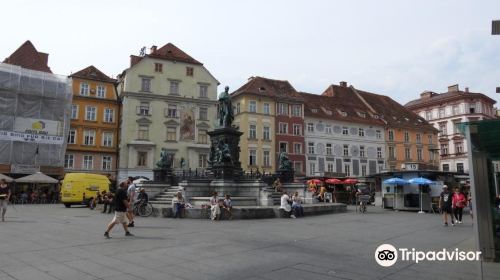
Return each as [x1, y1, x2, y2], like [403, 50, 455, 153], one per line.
[3, 40, 52, 73]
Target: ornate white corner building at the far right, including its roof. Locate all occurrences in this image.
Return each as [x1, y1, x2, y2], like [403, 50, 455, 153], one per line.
[405, 85, 496, 173]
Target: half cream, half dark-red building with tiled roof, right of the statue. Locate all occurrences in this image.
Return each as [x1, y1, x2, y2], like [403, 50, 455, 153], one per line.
[232, 77, 305, 176]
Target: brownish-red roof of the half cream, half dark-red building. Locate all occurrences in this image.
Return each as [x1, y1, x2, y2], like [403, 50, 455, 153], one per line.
[231, 77, 303, 102]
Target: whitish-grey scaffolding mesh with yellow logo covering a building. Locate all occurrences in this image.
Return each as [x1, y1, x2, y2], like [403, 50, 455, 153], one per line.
[0, 63, 72, 167]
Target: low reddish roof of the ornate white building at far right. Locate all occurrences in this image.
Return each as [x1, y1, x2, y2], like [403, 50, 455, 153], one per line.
[405, 91, 496, 110]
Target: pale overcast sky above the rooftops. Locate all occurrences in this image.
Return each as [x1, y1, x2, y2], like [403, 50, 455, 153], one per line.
[0, 0, 500, 105]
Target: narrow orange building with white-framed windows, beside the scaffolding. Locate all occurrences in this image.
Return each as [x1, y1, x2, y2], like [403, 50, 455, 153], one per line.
[64, 66, 120, 181]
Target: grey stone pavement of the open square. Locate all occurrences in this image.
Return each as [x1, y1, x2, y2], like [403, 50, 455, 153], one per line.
[0, 205, 500, 280]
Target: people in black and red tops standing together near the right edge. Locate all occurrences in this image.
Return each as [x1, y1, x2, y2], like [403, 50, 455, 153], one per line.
[438, 185, 473, 226]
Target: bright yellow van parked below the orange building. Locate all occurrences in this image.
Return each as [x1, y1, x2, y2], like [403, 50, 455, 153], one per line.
[61, 173, 111, 208]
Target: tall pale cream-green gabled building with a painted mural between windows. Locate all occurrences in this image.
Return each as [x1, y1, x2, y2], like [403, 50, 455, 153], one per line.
[118, 43, 219, 179]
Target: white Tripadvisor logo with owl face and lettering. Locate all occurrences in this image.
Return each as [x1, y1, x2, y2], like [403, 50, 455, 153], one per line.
[375, 244, 481, 267]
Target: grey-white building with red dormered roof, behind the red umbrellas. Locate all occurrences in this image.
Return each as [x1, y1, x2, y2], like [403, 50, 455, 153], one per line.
[301, 88, 385, 177]
